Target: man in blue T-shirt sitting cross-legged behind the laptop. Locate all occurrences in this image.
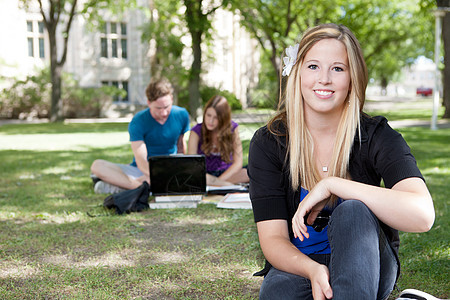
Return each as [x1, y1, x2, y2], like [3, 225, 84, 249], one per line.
[91, 79, 189, 193]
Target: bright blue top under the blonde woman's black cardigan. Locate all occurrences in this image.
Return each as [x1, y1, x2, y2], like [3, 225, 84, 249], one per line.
[291, 188, 342, 255]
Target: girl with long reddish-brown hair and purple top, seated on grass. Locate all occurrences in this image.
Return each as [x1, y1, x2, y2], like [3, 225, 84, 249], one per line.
[187, 96, 249, 186]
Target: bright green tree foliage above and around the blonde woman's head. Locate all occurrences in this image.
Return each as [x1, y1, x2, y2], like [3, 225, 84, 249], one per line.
[230, 0, 435, 106]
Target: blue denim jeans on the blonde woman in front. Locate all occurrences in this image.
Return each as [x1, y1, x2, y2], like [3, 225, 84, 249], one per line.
[259, 200, 399, 300]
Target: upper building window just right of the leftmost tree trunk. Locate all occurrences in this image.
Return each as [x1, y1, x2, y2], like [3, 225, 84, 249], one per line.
[100, 22, 128, 59]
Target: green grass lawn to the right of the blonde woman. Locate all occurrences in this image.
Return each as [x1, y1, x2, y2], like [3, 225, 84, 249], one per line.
[392, 128, 450, 298]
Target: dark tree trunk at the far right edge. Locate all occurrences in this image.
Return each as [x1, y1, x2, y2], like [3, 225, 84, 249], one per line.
[442, 12, 450, 119]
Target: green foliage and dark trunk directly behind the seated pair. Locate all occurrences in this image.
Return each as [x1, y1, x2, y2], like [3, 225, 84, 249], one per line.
[146, 0, 232, 117]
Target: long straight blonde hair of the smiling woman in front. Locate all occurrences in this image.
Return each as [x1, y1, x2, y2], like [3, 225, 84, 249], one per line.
[268, 24, 368, 196]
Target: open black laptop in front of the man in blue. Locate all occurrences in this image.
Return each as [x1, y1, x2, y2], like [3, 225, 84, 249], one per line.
[148, 154, 206, 196]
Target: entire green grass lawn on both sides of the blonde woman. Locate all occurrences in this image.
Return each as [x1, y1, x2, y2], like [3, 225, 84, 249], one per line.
[0, 105, 450, 299]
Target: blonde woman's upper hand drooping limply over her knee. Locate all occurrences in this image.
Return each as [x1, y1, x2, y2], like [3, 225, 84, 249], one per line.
[292, 179, 331, 241]
